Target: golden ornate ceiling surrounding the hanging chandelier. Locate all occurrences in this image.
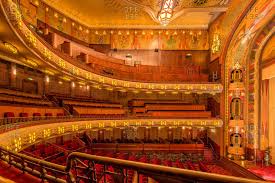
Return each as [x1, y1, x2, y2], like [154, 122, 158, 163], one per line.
[43, 0, 229, 29]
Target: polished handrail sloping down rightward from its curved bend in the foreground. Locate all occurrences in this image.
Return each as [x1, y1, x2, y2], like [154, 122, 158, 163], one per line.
[66, 152, 266, 183]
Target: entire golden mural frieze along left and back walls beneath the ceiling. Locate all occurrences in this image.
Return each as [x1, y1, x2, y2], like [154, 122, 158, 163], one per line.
[20, 0, 209, 50]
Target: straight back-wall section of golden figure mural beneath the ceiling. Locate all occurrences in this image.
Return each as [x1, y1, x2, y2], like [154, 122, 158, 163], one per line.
[111, 30, 209, 50]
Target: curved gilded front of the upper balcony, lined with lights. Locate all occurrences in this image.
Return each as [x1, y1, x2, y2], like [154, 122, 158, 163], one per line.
[1, 0, 223, 94]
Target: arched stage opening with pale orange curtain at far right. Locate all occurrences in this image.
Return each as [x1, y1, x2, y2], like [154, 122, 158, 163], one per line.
[258, 34, 275, 164]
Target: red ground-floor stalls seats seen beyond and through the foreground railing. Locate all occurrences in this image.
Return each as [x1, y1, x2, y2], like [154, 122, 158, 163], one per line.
[24, 140, 232, 183]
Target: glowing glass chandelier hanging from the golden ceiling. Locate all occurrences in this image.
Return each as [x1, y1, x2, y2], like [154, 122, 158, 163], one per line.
[158, 0, 176, 26]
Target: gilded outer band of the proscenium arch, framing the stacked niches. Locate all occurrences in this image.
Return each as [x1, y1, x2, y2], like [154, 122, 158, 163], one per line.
[223, 1, 274, 155]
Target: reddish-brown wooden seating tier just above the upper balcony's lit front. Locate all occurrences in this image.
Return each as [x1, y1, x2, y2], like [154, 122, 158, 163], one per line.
[41, 28, 208, 82]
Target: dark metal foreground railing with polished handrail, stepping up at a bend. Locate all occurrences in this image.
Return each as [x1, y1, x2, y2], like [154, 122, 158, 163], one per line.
[0, 147, 266, 183]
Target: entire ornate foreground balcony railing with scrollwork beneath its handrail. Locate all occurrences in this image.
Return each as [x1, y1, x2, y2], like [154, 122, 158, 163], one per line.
[0, 147, 266, 183]
